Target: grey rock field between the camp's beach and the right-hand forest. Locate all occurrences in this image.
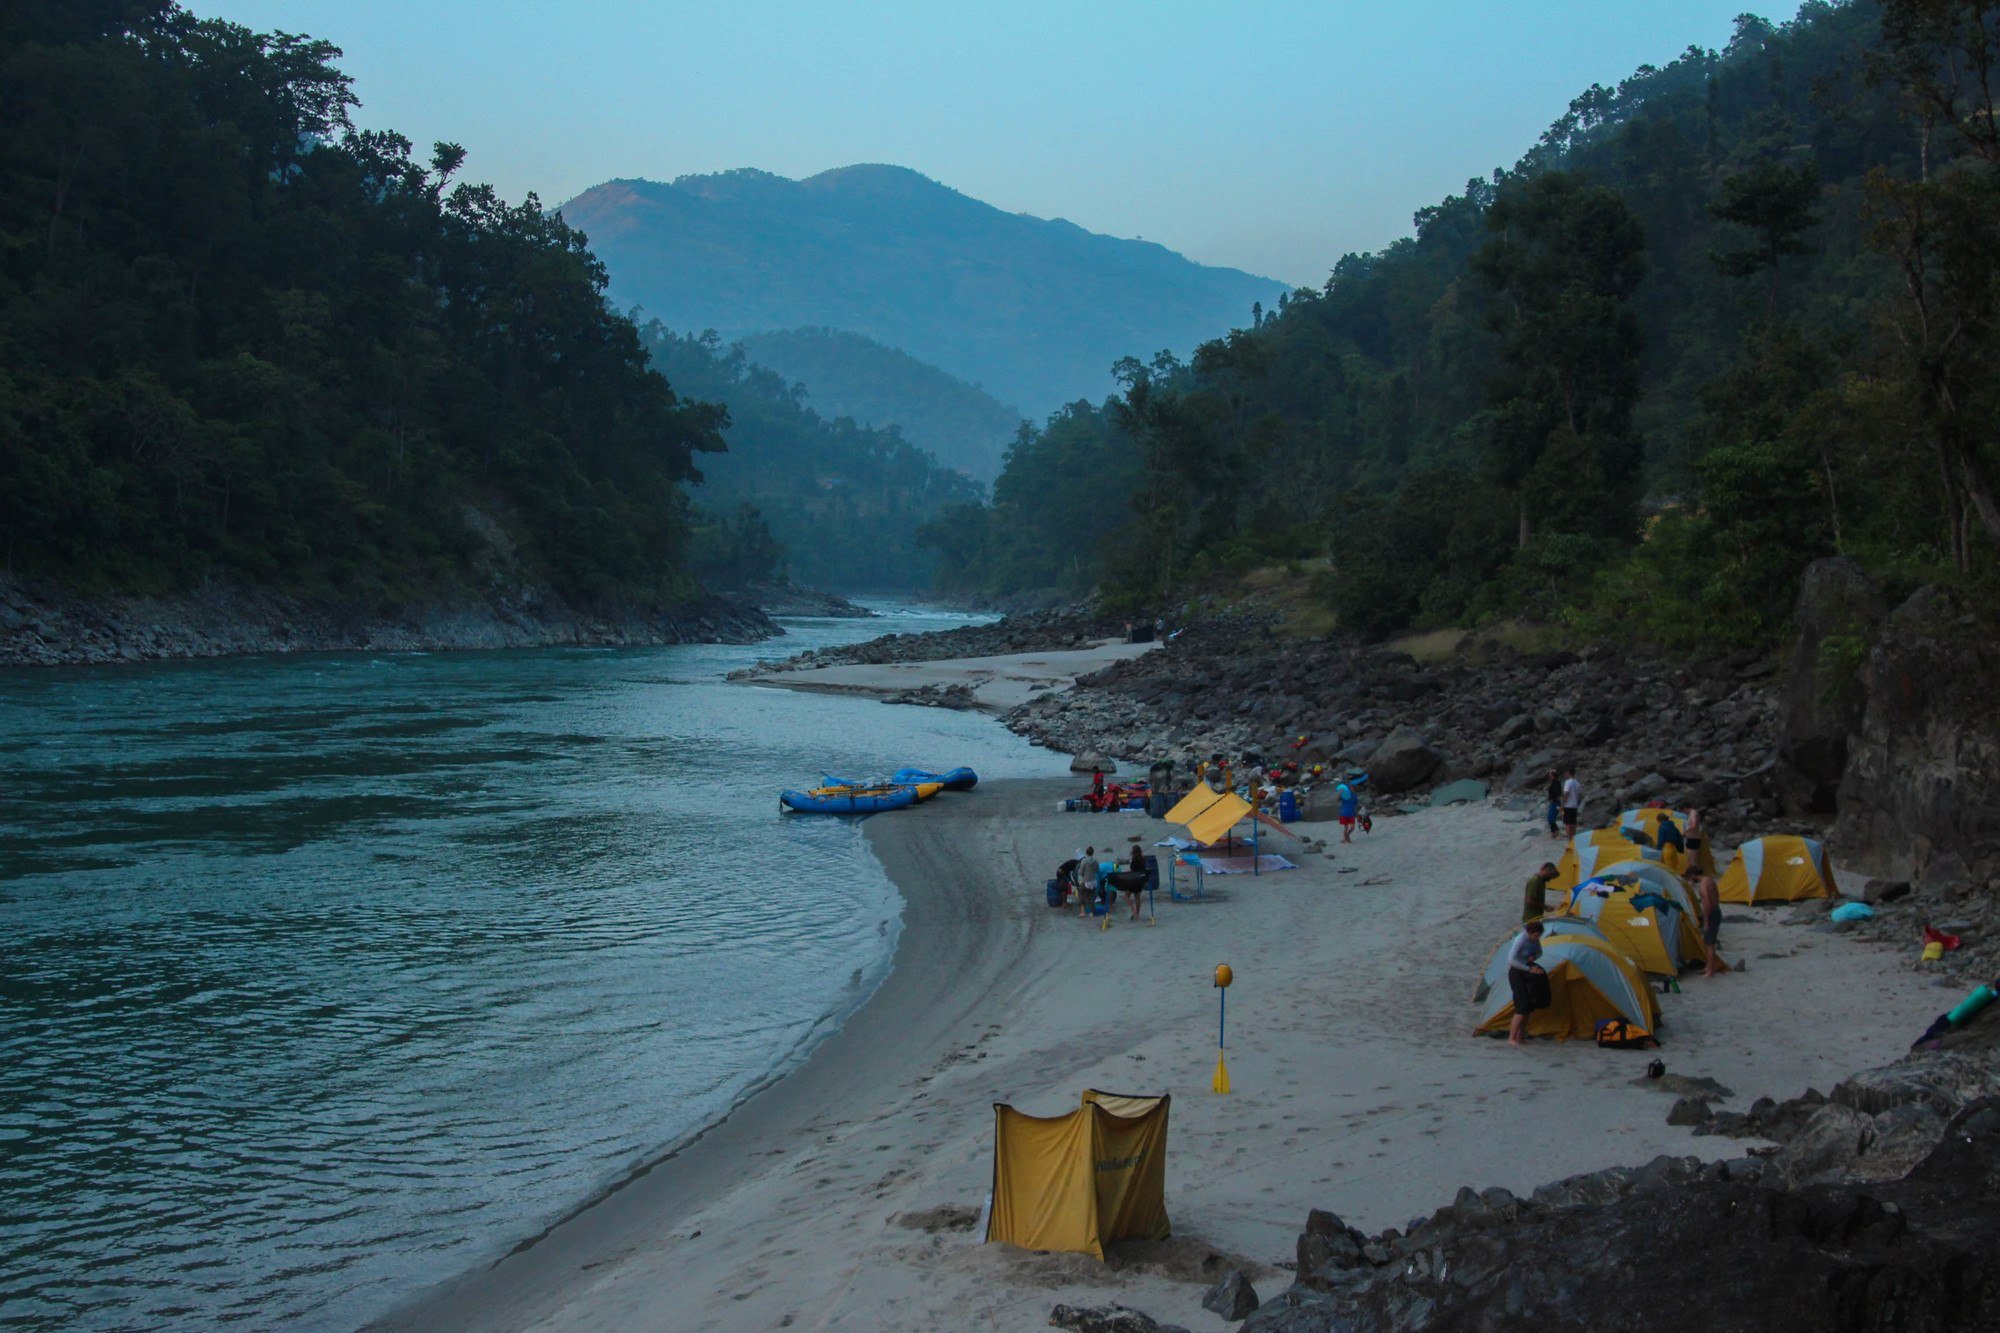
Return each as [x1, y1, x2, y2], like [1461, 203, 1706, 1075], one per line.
[1004, 610, 1780, 831]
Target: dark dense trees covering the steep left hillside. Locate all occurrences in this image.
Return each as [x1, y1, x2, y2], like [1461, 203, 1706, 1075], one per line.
[0, 0, 722, 598]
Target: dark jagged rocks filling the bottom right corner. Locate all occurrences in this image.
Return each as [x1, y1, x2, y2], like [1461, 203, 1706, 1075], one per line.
[1242, 1099, 2000, 1333]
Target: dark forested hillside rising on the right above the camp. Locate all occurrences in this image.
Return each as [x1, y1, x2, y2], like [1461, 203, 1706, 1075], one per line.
[932, 0, 2000, 644]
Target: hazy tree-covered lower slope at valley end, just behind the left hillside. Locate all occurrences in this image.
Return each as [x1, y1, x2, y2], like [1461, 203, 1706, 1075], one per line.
[646, 322, 980, 590]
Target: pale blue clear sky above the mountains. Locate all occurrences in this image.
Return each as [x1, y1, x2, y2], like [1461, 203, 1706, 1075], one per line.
[190, 0, 1796, 286]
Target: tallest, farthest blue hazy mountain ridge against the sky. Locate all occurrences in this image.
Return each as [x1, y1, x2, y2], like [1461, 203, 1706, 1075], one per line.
[562, 164, 1288, 416]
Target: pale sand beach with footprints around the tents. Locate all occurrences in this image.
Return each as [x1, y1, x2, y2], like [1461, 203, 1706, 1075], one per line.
[386, 781, 1946, 1329]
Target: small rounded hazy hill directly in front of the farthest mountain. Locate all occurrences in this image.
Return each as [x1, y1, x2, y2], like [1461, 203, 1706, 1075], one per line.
[742, 328, 1020, 482]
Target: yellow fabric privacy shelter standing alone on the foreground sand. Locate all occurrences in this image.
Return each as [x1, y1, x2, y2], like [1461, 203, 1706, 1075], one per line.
[986, 1089, 1172, 1261]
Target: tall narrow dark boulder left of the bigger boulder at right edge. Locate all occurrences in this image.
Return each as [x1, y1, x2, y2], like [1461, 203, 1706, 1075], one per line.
[1774, 556, 1888, 815]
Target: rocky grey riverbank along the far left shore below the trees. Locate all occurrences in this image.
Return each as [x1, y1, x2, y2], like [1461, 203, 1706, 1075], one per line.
[0, 578, 780, 667]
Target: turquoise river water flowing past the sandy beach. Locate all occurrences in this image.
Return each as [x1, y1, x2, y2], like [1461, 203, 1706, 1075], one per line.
[0, 608, 1060, 1329]
